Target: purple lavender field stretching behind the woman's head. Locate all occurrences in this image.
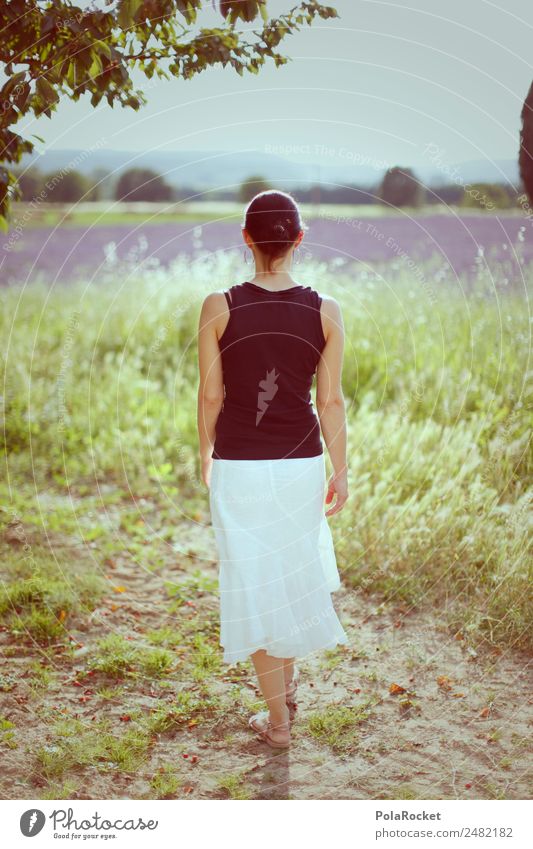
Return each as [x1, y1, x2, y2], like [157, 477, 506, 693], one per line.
[0, 207, 533, 285]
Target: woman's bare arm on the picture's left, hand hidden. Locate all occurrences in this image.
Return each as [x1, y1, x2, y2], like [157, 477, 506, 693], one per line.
[197, 292, 227, 488]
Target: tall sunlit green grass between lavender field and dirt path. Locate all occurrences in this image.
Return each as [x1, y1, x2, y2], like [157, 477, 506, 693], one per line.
[1, 256, 533, 646]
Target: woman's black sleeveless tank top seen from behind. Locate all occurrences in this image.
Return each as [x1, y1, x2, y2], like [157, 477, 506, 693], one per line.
[211, 281, 326, 460]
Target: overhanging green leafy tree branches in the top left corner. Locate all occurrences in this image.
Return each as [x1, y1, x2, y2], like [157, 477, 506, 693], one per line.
[0, 0, 337, 229]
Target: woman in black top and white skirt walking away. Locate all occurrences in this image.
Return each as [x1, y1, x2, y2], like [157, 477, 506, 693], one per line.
[198, 191, 348, 748]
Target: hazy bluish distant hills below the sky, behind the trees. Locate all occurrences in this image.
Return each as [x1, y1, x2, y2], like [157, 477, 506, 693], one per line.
[22, 148, 518, 190]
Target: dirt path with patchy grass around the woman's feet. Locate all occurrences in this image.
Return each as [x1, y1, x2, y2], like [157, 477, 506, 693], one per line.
[0, 510, 533, 799]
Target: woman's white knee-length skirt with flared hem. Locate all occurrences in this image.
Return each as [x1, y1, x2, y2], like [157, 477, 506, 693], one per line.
[209, 454, 348, 664]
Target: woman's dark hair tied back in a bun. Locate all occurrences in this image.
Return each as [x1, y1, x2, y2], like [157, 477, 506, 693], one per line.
[243, 189, 305, 271]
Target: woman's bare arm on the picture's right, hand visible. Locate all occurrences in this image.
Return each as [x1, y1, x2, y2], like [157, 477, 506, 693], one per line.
[316, 295, 348, 516]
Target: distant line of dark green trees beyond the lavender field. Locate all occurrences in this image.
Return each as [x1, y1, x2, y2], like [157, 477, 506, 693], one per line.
[12, 167, 520, 210]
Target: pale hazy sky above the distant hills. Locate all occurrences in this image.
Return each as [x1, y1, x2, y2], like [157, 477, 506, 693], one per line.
[19, 0, 533, 165]
